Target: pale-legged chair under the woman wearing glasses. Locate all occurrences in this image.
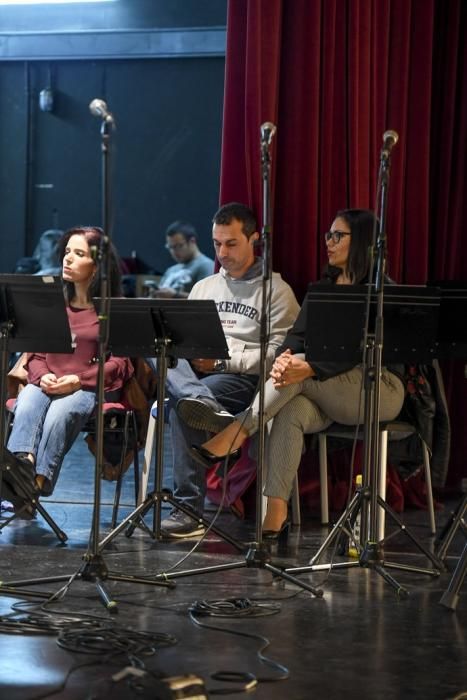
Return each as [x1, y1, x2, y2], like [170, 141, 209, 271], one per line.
[318, 420, 436, 539]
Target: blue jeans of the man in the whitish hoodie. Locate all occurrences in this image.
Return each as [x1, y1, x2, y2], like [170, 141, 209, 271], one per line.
[148, 360, 258, 513]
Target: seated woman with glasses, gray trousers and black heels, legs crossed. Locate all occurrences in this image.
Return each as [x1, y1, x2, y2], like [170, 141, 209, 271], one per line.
[191, 209, 405, 540]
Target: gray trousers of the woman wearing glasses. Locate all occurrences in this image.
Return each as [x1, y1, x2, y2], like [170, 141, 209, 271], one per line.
[241, 360, 405, 501]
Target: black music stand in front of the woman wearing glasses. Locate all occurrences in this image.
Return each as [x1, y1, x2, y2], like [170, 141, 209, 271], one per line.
[287, 285, 444, 594]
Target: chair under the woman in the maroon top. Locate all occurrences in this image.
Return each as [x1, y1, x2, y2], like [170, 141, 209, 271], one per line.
[6, 399, 139, 539]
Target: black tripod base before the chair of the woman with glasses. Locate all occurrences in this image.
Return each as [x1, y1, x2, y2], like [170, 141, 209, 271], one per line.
[286, 487, 444, 596]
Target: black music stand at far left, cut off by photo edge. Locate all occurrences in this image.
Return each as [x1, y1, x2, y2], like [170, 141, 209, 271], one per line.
[0, 274, 73, 542]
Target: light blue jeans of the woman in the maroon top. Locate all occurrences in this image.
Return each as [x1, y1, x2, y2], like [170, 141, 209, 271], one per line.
[7, 384, 96, 496]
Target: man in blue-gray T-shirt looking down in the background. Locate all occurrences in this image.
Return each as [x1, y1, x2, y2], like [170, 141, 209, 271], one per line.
[151, 221, 214, 299]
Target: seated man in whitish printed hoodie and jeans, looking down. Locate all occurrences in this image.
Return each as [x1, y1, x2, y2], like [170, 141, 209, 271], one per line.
[161, 202, 299, 537]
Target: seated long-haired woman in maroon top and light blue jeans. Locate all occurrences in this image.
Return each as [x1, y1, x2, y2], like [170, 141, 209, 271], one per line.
[7, 226, 133, 506]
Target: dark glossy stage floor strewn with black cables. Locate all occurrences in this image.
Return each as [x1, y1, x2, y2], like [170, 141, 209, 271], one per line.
[0, 438, 467, 700]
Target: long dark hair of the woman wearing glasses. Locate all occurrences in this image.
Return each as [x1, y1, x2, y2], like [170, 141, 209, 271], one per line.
[325, 209, 377, 284]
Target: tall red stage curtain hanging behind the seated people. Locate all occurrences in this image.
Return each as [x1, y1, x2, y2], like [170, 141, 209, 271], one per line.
[220, 0, 467, 486]
